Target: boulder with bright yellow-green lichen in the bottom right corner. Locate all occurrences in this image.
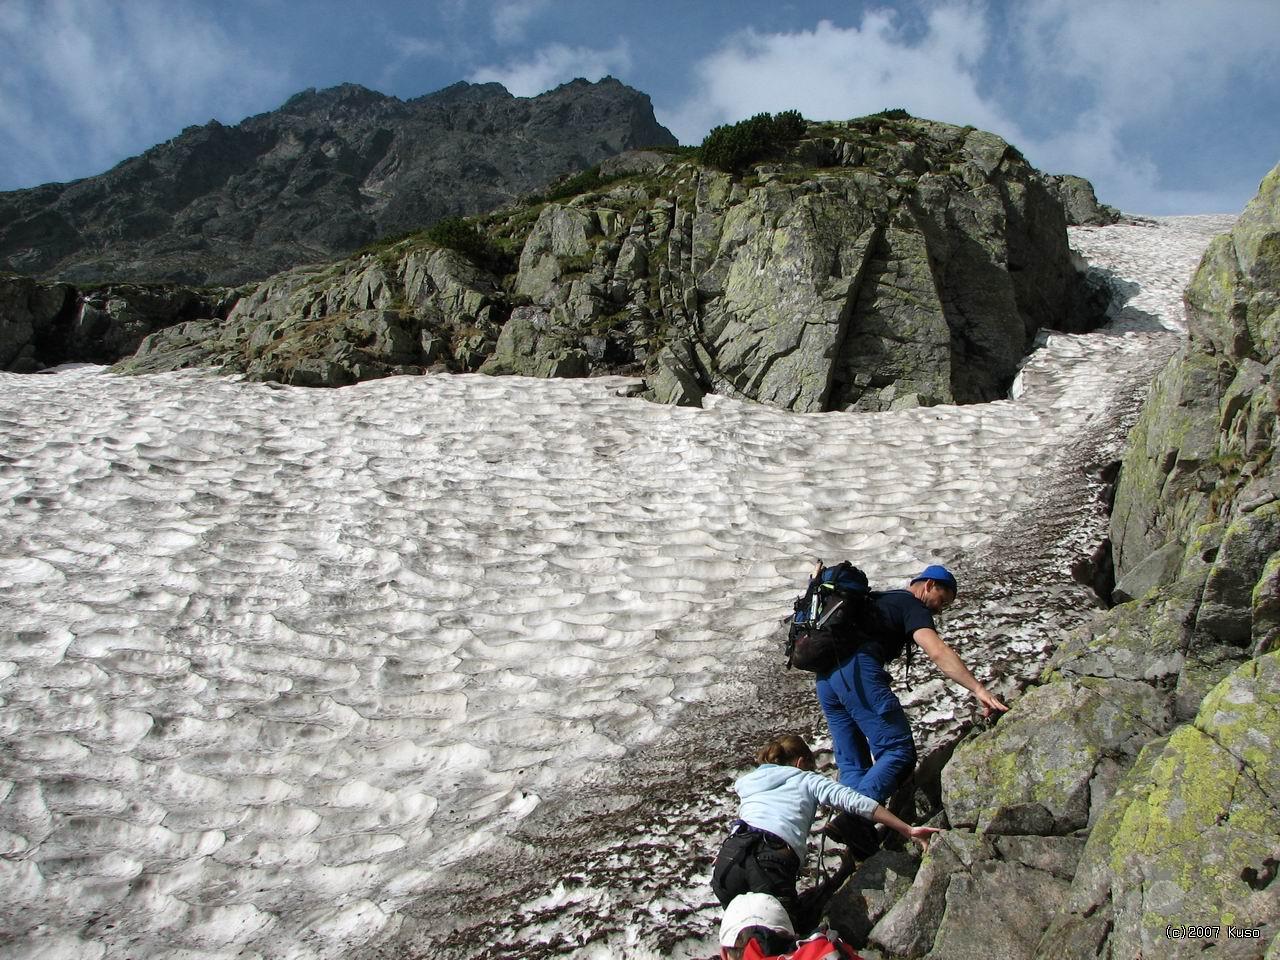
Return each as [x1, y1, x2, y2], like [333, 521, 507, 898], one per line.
[1037, 654, 1280, 960]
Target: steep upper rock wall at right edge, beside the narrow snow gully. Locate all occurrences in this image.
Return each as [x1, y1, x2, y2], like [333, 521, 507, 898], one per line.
[1111, 160, 1280, 583]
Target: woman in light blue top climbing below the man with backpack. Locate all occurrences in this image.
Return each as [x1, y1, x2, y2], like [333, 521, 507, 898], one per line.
[712, 733, 938, 932]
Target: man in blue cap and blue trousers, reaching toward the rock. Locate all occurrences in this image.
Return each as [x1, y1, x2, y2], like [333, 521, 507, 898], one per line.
[818, 564, 1009, 856]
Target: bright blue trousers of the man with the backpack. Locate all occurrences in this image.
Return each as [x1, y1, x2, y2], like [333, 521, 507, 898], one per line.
[818, 653, 915, 804]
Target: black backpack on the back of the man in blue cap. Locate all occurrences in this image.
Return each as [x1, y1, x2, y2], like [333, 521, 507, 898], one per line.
[786, 561, 874, 673]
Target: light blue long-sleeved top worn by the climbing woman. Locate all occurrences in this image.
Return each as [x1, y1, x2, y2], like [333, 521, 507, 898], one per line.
[733, 763, 877, 861]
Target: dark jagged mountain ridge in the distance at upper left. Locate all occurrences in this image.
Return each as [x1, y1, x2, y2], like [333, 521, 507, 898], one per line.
[0, 78, 676, 284]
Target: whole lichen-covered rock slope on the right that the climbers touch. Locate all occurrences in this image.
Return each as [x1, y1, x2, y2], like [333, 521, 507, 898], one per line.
[832, 161, 1280, 960]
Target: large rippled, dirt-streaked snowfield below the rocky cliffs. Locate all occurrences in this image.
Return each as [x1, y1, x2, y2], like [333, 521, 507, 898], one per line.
[0, 218, 1230, 960]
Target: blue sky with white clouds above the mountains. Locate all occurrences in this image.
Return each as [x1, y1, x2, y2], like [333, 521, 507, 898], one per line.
[0, 0, 1280, 214]
